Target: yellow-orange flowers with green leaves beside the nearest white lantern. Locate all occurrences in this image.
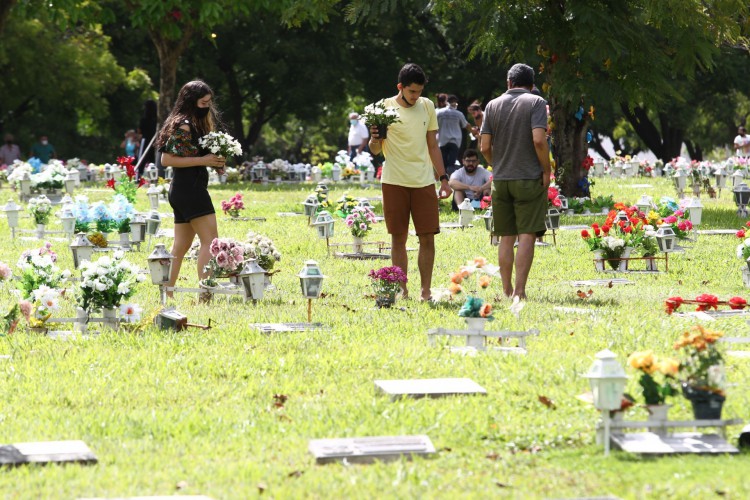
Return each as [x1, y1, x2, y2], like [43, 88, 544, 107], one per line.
[628, 351, 680, 405]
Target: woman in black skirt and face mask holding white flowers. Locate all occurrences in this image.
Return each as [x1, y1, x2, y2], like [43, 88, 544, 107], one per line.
[157, 80, 225, 297]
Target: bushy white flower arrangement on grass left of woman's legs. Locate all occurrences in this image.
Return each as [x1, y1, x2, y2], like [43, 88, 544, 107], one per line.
[78, 250, 145, 312]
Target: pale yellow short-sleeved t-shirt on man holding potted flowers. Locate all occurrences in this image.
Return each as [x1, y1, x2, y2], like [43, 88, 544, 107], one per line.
[381, 97, 438, 188]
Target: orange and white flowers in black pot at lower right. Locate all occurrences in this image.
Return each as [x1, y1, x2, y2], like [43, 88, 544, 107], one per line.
[674, 325, 726, 420]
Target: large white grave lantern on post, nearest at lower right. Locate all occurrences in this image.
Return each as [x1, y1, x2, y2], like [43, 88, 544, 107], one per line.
[584, 349, 628, 455]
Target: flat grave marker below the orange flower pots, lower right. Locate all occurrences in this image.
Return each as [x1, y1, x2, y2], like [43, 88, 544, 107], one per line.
[612, 432, 739, 455]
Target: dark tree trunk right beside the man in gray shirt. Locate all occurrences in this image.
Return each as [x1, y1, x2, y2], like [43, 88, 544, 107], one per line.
[550, 97, 589, 198]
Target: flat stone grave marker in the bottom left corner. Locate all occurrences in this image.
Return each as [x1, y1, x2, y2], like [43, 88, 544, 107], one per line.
[0, 441, 97, 466]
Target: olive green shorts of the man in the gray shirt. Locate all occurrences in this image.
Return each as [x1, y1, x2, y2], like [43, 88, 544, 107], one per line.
[492, 179, 547, 236]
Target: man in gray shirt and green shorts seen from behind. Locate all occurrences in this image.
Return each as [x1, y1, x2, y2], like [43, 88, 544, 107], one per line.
[481, 60, 551, 300]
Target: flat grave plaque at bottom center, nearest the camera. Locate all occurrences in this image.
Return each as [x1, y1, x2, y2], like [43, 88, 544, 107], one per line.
[308, 435, 435, 464]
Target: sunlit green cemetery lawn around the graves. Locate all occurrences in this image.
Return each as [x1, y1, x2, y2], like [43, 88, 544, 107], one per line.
[0, 178, 750, 499]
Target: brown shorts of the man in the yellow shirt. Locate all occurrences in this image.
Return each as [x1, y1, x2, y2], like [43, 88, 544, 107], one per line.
[381, 184, 440, 235]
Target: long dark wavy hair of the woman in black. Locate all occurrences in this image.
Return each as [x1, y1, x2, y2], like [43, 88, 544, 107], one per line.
[157, 80, 218, 149]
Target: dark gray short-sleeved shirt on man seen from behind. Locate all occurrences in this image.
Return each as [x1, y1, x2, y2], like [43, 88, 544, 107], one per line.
[482, 88, 547, 181]
